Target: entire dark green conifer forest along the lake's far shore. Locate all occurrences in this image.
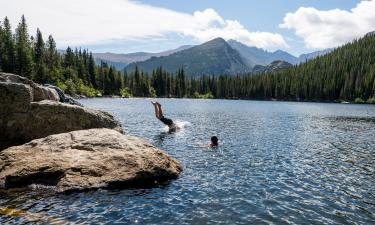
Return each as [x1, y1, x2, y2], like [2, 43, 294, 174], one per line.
[0, 16, 375, 103]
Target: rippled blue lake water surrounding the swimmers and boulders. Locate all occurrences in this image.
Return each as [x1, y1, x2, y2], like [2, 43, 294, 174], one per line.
[0, 98, 375, 224]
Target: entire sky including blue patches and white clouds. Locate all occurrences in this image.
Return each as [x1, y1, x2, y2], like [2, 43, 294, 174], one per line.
[0, 0, 375, 56]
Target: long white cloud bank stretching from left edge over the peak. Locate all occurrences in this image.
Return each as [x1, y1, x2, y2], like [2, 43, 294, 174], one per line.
[0, 0, 288, 48]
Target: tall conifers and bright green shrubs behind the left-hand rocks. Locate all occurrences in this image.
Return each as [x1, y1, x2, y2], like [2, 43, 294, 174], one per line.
[0, 16, 121, 96]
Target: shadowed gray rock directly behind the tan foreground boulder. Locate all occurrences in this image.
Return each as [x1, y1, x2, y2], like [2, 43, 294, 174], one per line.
[0, 100, 122, 149]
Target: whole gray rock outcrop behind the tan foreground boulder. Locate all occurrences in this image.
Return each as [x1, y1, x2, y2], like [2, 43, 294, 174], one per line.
[0, 73, 122, 150]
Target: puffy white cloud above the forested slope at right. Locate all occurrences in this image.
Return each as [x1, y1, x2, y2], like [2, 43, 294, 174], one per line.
[280, 1, 375, 48]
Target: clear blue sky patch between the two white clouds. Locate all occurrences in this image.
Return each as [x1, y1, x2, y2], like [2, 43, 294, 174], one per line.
[141, 0, 360, 55]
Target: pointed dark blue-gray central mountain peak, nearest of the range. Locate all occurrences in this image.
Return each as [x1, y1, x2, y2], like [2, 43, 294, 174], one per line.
[126, 38, 251, 76]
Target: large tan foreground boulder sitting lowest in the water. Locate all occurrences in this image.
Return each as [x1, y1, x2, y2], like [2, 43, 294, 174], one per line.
[0, 129, 182, 192]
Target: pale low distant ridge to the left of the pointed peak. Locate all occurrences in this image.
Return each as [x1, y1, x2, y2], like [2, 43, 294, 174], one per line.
[93, 45, 192, 70]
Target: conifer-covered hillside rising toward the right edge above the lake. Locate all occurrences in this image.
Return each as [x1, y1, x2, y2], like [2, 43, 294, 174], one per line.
[206, 33, 375, 103]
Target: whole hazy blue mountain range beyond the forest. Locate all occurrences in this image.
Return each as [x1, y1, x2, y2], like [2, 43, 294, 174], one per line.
[97, 38, 332, 75]
